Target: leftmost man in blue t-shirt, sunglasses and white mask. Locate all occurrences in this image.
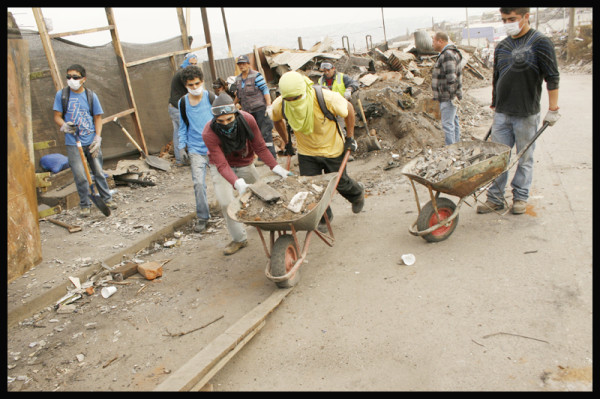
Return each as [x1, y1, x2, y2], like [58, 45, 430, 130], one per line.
[53, 64, 117, 217]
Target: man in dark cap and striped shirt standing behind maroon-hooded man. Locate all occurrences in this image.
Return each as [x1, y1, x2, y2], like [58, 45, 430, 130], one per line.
[234, 55, 277, 162]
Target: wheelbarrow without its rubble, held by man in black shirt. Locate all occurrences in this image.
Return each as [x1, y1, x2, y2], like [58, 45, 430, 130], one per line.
[402, 122, 549, 242]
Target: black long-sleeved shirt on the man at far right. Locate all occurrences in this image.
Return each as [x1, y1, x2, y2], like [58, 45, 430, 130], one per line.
[492, 29, 559, 116]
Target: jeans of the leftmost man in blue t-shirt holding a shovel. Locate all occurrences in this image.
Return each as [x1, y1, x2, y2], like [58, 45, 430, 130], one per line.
[66, 145, 112, 208]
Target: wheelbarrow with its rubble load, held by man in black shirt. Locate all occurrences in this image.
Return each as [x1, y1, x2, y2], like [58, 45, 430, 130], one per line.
[402, 122, 549, 242]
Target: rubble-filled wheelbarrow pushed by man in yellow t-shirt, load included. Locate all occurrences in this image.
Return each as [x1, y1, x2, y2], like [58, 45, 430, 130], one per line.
[227, 151, 350, 288]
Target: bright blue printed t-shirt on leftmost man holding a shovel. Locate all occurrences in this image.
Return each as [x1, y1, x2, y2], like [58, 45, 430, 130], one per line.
[53, 87, 104, 145]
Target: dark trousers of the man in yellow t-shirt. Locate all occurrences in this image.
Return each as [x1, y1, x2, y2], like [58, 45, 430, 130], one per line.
[298, 152, 363, 222]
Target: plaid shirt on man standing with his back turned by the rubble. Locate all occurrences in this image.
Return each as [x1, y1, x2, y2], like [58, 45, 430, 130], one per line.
[431, 44, 462, 102]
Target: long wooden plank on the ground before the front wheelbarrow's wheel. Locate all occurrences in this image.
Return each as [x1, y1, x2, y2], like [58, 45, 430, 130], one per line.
[154, 287, 293, 391]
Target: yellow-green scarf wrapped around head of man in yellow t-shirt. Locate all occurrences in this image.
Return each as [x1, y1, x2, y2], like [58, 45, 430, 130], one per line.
[279, 71, 315, 135]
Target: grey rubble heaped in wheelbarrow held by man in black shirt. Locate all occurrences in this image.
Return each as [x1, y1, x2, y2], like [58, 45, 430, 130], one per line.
[410, 146, 495, 183]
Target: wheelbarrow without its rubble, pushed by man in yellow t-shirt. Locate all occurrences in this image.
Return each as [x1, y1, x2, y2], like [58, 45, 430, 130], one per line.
[227, 150, 350, 288]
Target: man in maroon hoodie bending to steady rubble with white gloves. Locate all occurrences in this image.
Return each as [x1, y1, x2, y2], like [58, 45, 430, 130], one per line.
[202, 93, 291, 255]
